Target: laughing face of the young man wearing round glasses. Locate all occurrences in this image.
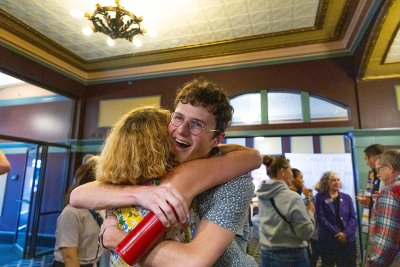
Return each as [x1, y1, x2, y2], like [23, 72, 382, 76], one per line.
[169, 103, 224, 163]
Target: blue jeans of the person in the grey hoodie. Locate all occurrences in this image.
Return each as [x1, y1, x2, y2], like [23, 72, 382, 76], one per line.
[261, 247, 309, 267]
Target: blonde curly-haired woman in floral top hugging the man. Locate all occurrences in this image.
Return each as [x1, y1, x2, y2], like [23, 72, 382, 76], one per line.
[96, 107, 261, 266]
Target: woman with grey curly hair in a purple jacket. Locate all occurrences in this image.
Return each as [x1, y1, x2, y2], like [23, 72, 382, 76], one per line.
[315, 171, 357, 267]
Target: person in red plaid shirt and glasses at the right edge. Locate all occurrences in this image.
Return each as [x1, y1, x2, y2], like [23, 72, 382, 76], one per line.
[367, 150, 400, 267]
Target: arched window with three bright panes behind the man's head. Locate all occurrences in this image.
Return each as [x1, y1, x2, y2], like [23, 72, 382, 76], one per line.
[231, 90, 350, 125]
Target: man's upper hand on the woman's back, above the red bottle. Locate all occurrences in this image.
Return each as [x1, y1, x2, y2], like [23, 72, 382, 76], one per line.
[137, 182, 189, 227]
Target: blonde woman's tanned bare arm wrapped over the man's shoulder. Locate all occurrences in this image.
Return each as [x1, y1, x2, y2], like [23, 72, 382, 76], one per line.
[163, 145, 262, 206]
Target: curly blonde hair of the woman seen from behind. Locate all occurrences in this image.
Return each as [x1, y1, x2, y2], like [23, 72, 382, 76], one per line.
[96, 107, 178, 185]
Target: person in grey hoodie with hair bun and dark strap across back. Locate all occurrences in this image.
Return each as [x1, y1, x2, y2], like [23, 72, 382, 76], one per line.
[257, 156, 314, 267]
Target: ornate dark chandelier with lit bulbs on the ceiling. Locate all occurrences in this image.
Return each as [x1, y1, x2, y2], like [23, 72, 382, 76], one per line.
[85, 0, 146, 42]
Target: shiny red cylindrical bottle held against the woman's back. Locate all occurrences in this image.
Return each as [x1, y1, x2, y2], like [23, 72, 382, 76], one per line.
[115, 211, 165, 266]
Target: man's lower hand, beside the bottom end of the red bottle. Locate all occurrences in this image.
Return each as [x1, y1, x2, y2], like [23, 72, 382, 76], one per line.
[100, 211, 127, 250]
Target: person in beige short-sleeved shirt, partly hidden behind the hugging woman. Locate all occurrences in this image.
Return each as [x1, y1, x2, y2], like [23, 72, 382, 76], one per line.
[53, 156, 103, 267]
